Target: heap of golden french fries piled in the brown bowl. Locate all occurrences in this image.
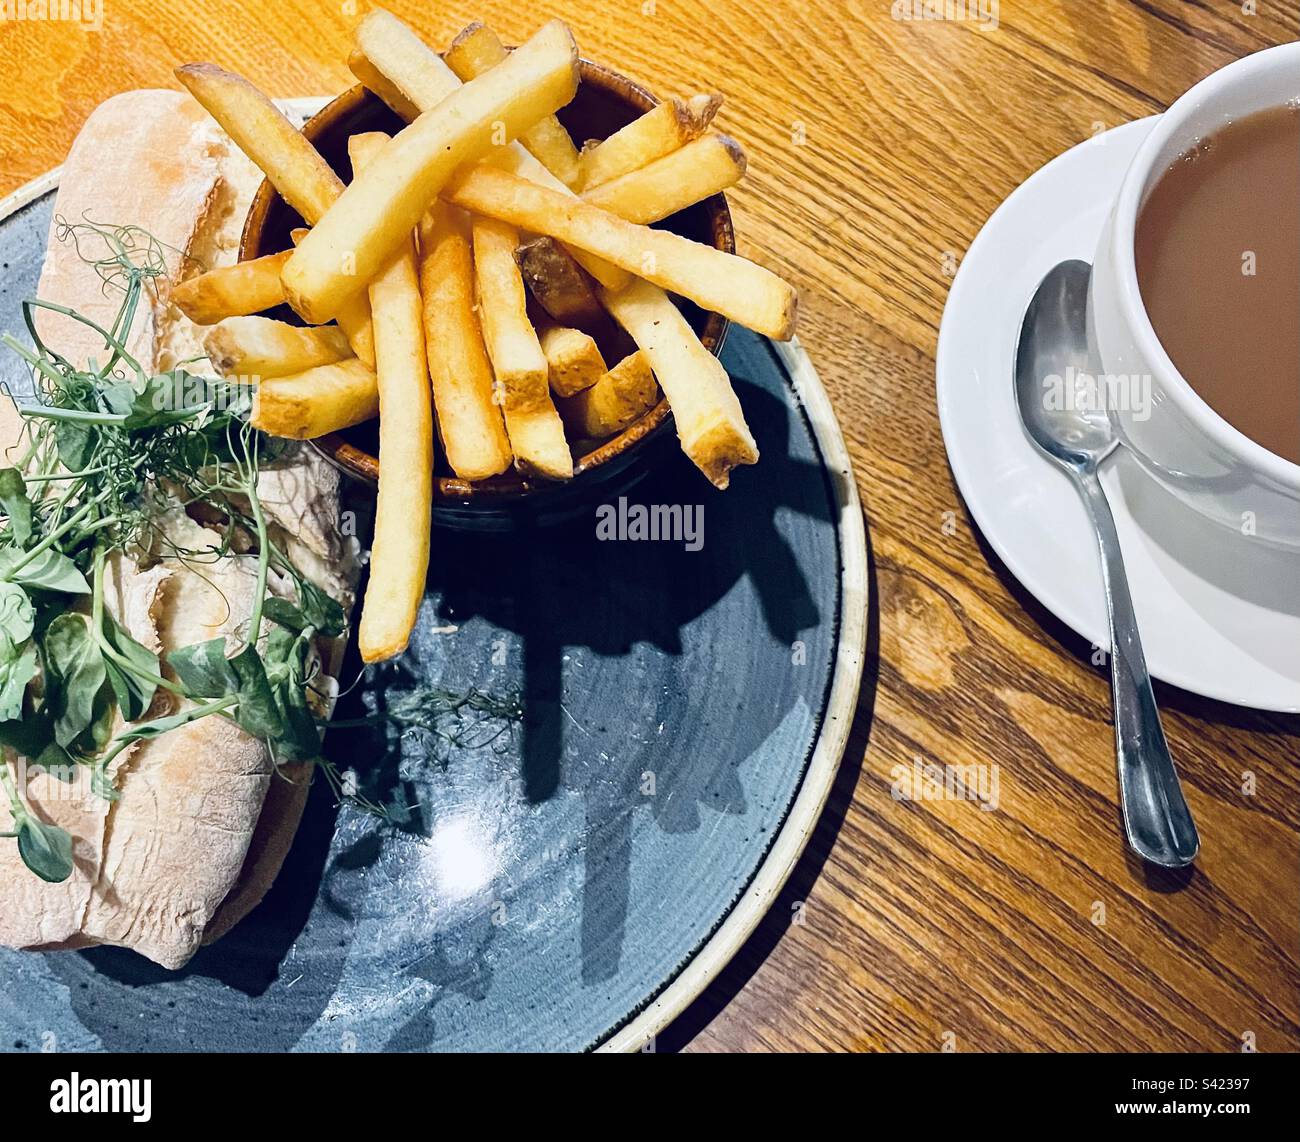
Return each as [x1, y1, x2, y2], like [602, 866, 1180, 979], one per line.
[172, 9, 797, 662]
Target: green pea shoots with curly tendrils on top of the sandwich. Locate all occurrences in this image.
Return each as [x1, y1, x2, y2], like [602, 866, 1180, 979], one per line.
[0, 222, 346, 882]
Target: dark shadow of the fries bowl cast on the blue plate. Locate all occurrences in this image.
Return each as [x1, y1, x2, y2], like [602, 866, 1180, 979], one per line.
[325, 371, 833, 998]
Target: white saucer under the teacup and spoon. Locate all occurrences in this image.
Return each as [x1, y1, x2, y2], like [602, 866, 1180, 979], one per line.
[936, 118, 1300, 713]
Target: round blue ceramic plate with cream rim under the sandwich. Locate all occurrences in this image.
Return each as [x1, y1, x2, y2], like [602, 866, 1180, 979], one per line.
[0, 170, 867, 1051]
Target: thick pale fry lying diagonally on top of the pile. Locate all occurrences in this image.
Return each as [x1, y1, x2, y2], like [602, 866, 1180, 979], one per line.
[281, 21, 577, 321]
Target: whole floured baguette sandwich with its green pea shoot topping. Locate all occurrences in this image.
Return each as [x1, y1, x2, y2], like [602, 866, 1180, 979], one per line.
[0, 91, 359, 969]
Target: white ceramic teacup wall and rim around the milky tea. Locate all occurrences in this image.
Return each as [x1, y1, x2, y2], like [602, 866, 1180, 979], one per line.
[1088, 43, 1300, 551]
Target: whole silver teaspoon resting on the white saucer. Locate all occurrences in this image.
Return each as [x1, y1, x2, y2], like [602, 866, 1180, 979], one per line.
[1015, 261, 1200, 869]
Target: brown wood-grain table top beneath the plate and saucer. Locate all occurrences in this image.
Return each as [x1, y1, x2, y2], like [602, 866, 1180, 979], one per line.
[0, 0, 1300, 1051]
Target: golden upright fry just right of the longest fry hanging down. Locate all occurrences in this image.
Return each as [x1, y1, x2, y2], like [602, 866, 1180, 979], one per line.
[420, 202, 512, 480]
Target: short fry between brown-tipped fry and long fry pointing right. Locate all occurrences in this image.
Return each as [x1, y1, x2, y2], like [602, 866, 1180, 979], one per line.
[582, 134, 745, 224]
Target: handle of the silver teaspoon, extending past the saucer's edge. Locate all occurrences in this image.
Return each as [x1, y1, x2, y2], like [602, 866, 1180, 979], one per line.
[1079, 471, 1201, 869]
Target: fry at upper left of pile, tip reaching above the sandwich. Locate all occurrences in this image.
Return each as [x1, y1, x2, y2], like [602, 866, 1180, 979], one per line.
[176, 64, 343, 227]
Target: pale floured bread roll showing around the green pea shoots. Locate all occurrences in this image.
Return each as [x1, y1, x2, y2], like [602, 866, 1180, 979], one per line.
[0, 91, 358, 968]
